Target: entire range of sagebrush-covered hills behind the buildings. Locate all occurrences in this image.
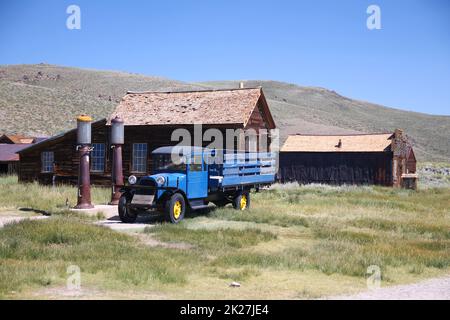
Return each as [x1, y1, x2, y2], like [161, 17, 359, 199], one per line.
[0, 64, 450, 162]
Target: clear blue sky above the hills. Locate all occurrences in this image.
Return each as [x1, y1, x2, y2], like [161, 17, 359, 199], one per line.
[0, 0, 450, 115]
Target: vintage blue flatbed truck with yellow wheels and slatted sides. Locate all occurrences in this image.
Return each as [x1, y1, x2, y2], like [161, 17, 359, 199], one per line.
[118, 146, 276, 223]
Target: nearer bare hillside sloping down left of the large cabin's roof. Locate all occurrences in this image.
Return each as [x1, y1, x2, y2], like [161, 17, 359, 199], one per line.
[0, 64, 202, 134]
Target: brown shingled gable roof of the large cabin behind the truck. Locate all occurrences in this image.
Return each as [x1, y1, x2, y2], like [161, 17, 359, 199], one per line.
[108, 88, 275, 128]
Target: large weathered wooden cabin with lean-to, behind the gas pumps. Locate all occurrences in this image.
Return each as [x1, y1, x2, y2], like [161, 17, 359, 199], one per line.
[19, 88, 275, 185]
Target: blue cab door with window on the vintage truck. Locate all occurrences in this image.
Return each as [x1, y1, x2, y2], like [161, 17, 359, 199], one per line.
[187, 154, 208, 199]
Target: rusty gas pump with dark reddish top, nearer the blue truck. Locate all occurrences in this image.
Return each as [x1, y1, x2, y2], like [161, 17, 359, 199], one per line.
[109, 117, 124, 205]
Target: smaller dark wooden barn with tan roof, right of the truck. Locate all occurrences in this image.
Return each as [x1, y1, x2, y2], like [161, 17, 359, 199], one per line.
[279, 130, 416, 186]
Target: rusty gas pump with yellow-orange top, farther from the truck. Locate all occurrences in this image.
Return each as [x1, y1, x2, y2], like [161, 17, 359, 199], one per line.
[75, 115, 94, 209]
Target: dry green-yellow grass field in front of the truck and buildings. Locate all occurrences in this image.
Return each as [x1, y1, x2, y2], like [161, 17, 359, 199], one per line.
[0, 178, 450, 299]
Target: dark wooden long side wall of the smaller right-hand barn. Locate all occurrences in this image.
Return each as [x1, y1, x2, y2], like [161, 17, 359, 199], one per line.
[278, 152, 392, 186]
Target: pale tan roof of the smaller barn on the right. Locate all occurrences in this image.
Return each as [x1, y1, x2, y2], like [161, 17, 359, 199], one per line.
[281, 133, 392, 152]
